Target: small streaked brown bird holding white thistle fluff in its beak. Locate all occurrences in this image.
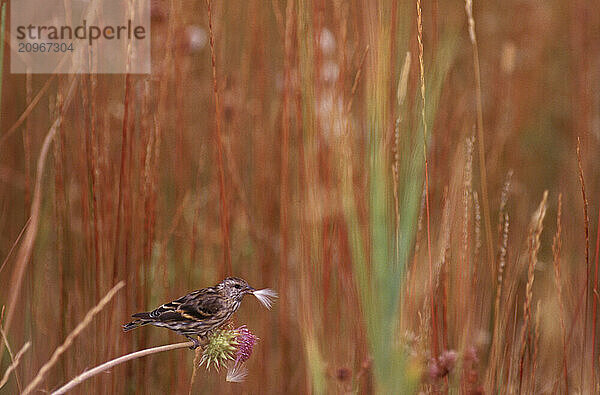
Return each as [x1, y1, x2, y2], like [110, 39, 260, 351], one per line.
[123, 277, 277, 349]
